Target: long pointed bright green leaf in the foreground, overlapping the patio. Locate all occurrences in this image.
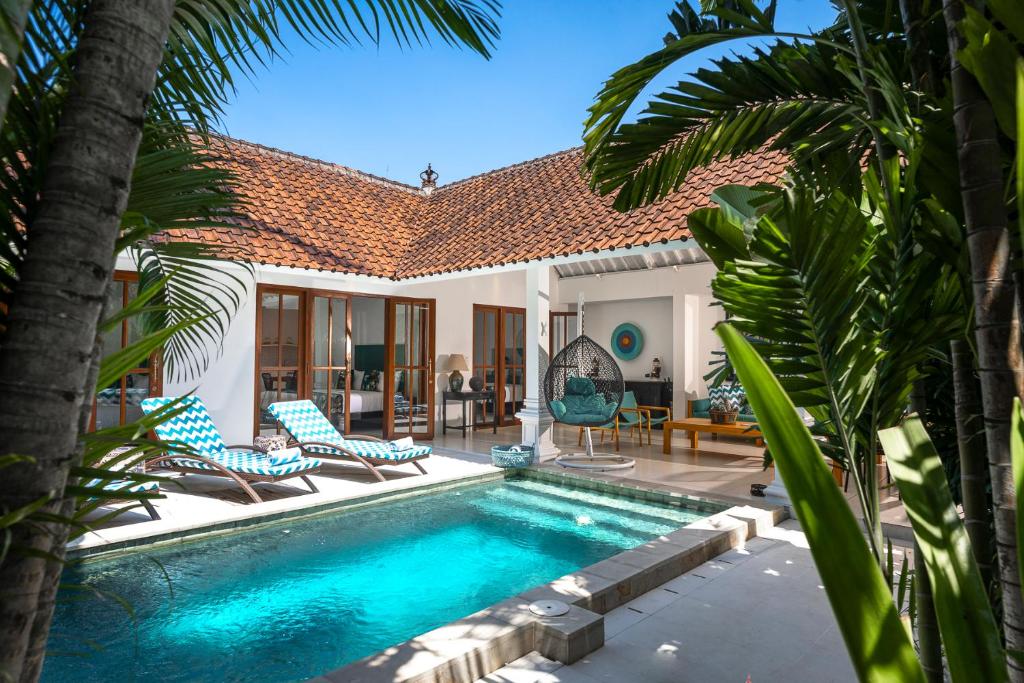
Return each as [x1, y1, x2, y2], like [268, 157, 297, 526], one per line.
[715, 324, 925, 683]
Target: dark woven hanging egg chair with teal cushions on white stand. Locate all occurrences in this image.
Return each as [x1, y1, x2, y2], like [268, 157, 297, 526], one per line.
[544, 335, 633, 470]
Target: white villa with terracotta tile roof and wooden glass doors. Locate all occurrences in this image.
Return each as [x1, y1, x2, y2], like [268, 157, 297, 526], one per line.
[103, 133, 781, 455]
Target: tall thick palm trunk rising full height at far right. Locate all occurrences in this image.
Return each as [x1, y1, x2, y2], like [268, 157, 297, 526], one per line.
[943, 0, 1024, 681]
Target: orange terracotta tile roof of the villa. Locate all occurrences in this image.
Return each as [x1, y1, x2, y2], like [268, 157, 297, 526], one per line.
[195, 138, 785, 279]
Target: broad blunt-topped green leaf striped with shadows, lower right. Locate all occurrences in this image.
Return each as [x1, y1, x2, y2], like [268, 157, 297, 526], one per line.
[879, 415, 1008, 683]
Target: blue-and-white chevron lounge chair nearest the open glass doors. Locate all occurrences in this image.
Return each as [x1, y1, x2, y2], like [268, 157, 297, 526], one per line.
[267, 400, 431, 481]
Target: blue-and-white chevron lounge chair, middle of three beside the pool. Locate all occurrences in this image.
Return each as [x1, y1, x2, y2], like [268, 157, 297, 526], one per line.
[141, 396, 321, 503]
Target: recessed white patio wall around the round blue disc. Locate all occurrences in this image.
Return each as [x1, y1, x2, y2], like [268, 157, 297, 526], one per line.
[584, 296, 673, 380]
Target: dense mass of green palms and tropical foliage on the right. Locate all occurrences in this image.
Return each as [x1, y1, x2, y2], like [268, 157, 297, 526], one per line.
[585, 0, 1024, 680]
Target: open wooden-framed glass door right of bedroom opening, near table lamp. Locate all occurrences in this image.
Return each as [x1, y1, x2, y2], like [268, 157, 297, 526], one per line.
[384, 299, 434, 438]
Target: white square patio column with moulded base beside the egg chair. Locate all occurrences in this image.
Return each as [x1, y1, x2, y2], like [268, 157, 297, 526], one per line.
[515, 265, 555, 458]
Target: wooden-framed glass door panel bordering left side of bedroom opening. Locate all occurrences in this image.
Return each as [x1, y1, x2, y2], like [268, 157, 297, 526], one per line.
[309, 295, 351, 434]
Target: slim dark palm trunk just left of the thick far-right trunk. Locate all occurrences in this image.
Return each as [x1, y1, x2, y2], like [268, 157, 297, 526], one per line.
[951, 339, 992, 587]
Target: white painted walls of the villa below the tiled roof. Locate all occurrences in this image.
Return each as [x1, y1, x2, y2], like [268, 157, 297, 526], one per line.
[149, 250, 722, 443]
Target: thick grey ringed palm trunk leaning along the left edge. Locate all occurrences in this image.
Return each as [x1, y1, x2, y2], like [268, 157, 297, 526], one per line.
[0, 0, 174, 681]
